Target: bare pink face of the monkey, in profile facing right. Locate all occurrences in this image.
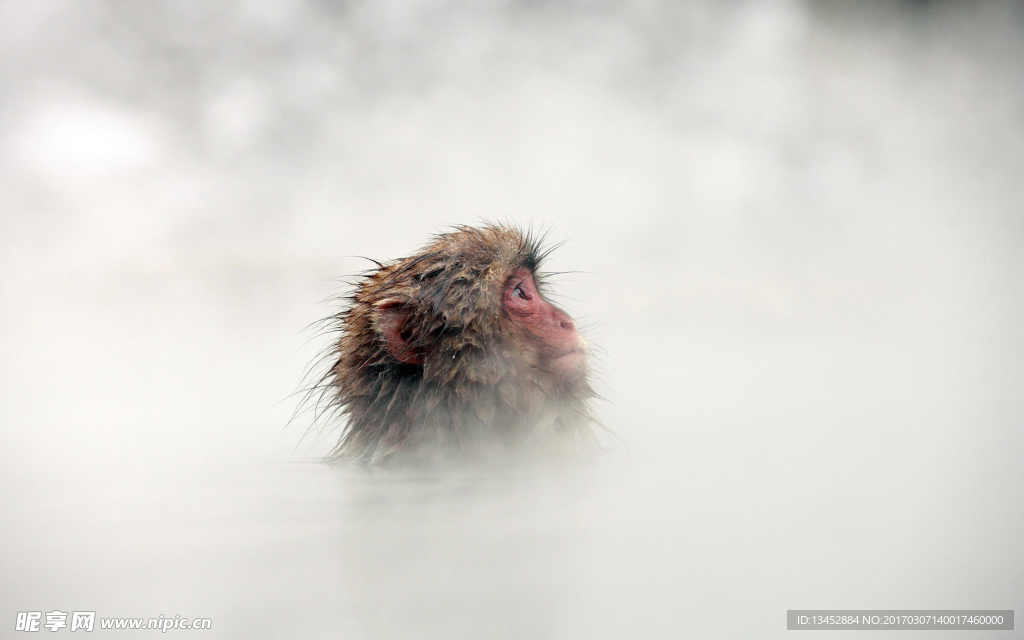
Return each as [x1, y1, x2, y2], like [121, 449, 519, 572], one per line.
[502, 268, 587, 375]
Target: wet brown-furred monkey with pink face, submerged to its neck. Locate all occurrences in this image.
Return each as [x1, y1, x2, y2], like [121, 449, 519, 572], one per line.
[311, 222, 599, 465]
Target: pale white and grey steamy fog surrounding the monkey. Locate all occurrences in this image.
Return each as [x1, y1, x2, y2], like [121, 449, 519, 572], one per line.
[0, 0, 1024, 640]
